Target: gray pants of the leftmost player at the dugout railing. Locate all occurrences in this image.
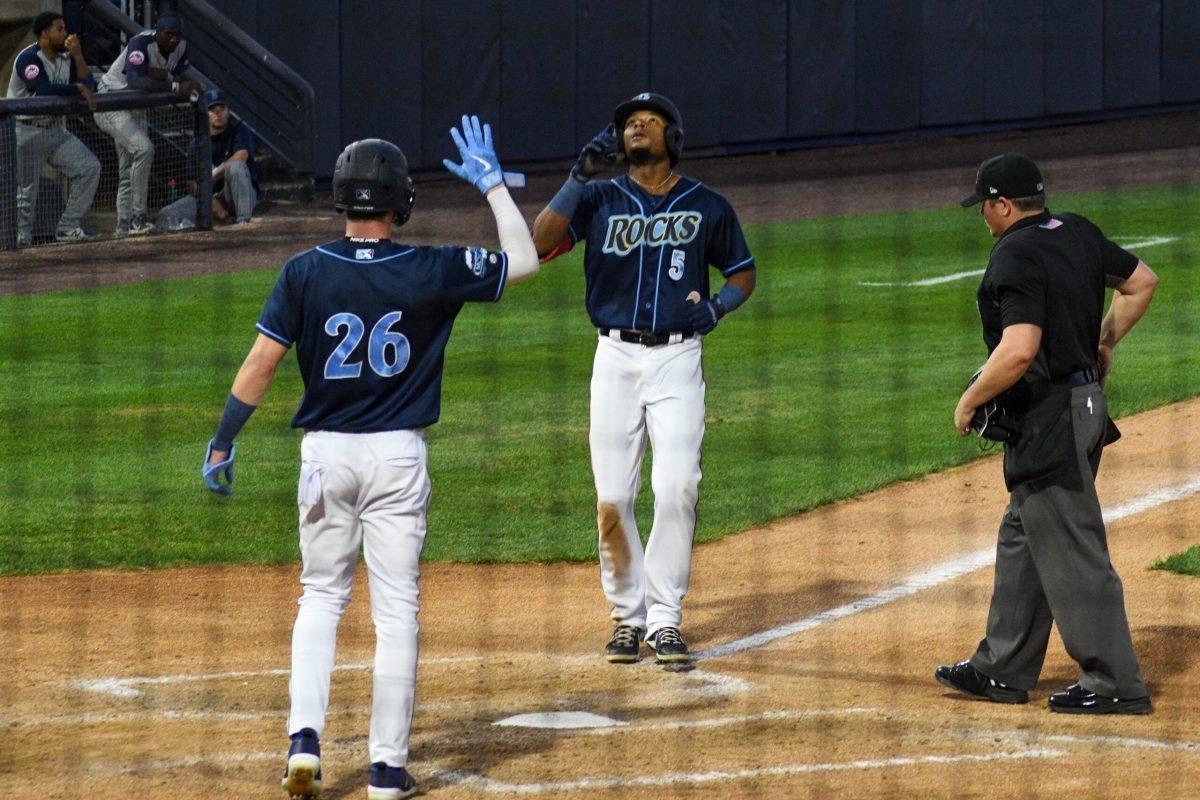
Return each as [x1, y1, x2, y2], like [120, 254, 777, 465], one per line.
[17, 121, 100, 239]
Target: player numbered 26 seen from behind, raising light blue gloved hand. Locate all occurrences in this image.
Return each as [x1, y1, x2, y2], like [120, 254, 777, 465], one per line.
[202, 118, 538, 800]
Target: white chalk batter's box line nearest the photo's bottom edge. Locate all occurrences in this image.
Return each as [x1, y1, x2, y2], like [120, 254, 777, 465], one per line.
[437, 748, 1067, 794]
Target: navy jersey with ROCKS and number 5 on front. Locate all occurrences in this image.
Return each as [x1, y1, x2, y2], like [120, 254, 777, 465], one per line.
[568, 175, 754, 333]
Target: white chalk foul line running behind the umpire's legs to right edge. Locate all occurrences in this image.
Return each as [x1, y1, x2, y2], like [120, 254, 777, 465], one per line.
[695, 477, 1200, 661]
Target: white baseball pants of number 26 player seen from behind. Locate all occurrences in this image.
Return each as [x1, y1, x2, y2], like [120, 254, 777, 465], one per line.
[288, 431, 430, 766]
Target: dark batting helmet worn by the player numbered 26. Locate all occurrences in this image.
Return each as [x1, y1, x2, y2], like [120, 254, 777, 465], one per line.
[334, 139, 415, 225]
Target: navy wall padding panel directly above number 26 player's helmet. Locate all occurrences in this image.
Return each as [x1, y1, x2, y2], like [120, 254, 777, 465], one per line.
[338, 0, 422, 163]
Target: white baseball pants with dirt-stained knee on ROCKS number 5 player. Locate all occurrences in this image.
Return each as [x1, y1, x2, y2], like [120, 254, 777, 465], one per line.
[589, 336, 704, 638]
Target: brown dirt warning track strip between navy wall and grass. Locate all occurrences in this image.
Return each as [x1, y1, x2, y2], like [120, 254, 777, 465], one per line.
[0, 113, 1200, 295]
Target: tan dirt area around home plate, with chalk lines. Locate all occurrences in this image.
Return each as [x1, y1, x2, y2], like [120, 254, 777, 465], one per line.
[0, 401, 1200, 800]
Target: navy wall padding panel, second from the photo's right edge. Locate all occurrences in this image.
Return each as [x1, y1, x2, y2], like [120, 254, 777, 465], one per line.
[1104, 0, 1163, 108]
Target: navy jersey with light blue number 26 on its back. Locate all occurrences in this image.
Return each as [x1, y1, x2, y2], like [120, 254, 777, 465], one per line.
[257, 239, 508, 433]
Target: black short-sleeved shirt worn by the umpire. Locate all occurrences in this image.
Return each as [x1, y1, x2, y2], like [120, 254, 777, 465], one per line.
[978, 210, 1138, 380]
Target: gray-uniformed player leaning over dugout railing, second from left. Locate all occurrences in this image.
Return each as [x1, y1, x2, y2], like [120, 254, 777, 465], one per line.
[96, 14, 200, 236]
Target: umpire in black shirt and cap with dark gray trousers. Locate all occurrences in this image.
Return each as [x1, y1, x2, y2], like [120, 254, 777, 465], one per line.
[935, 154, 1158, 714]
